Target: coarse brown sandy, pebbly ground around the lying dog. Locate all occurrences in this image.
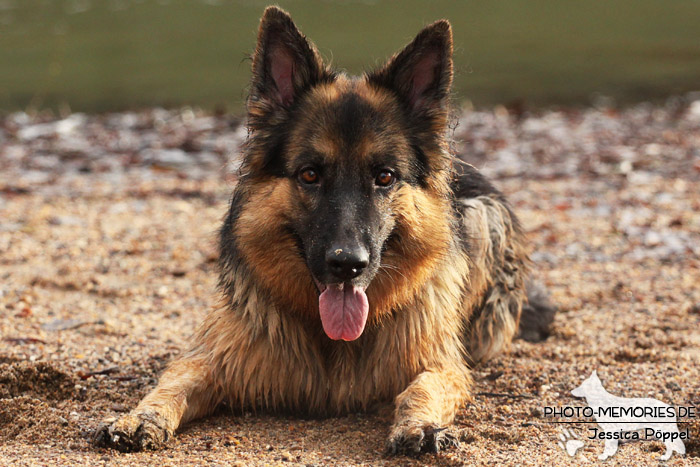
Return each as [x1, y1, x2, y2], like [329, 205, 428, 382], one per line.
[0, 104, 700, 466]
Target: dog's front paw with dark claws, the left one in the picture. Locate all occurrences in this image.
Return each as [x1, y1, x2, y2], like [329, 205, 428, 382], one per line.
[93, 413, 172, 452]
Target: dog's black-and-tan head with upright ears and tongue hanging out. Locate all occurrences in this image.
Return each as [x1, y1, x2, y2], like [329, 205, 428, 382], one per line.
[232, 7, 452, 340]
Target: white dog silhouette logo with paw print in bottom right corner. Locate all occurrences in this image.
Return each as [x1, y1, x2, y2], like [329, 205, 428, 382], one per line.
[559, 371, 694, 460]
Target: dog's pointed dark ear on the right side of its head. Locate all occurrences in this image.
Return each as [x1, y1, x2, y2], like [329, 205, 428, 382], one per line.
[368, 20, 452, 111]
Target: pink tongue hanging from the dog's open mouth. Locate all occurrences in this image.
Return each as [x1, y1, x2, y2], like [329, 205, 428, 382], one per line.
[318, 284, 369, 341]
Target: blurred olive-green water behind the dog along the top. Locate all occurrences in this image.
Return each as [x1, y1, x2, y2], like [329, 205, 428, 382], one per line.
[0, 0, 700, 111]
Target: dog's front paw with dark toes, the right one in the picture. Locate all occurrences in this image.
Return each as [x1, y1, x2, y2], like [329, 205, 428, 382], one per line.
[386, 420, 459, 456]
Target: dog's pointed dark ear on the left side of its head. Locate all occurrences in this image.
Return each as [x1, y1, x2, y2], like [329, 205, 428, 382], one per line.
[251, 6, 328, 108]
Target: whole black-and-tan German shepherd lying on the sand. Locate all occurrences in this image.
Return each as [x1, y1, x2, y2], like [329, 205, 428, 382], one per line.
[95, 7, 552, 453]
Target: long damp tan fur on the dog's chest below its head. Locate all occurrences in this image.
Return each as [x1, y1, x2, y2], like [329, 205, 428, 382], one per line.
[210, 243, 469, 415]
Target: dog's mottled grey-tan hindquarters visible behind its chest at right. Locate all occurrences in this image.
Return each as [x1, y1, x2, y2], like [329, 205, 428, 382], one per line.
[453, 163, 556, 365]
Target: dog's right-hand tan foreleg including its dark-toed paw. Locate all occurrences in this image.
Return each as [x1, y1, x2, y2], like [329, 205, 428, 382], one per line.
[387, 367, 471, 454]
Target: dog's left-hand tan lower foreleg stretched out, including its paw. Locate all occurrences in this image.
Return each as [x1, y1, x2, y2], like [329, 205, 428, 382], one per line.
[95, 356, 219, 452]
